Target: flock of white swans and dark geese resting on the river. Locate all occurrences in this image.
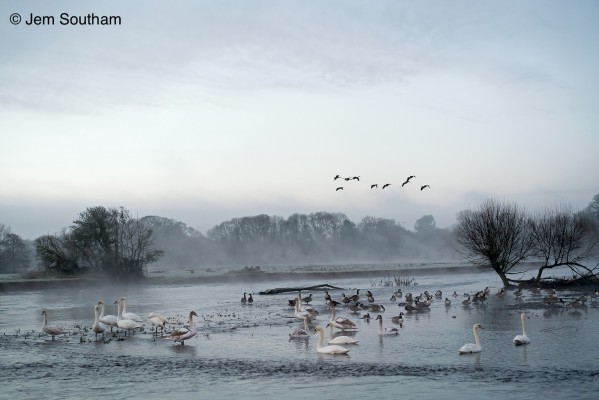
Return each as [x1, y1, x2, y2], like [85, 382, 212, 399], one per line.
[42, 287, 599, 354]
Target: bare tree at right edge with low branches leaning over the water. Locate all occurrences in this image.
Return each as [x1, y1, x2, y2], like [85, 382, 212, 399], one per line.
[531, 207, 597, 283]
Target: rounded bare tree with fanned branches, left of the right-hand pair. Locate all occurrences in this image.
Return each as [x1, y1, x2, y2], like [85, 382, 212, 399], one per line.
[455, 199, 532, 287]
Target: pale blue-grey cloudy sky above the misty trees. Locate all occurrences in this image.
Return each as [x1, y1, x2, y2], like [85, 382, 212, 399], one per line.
[0, 0, 599, 239]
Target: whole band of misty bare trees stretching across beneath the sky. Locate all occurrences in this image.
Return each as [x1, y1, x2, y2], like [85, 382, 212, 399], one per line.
[0, 194, 599, 286]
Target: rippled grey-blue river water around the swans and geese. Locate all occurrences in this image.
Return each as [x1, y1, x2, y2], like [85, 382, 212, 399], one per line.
[0, 267, 599, 400]
